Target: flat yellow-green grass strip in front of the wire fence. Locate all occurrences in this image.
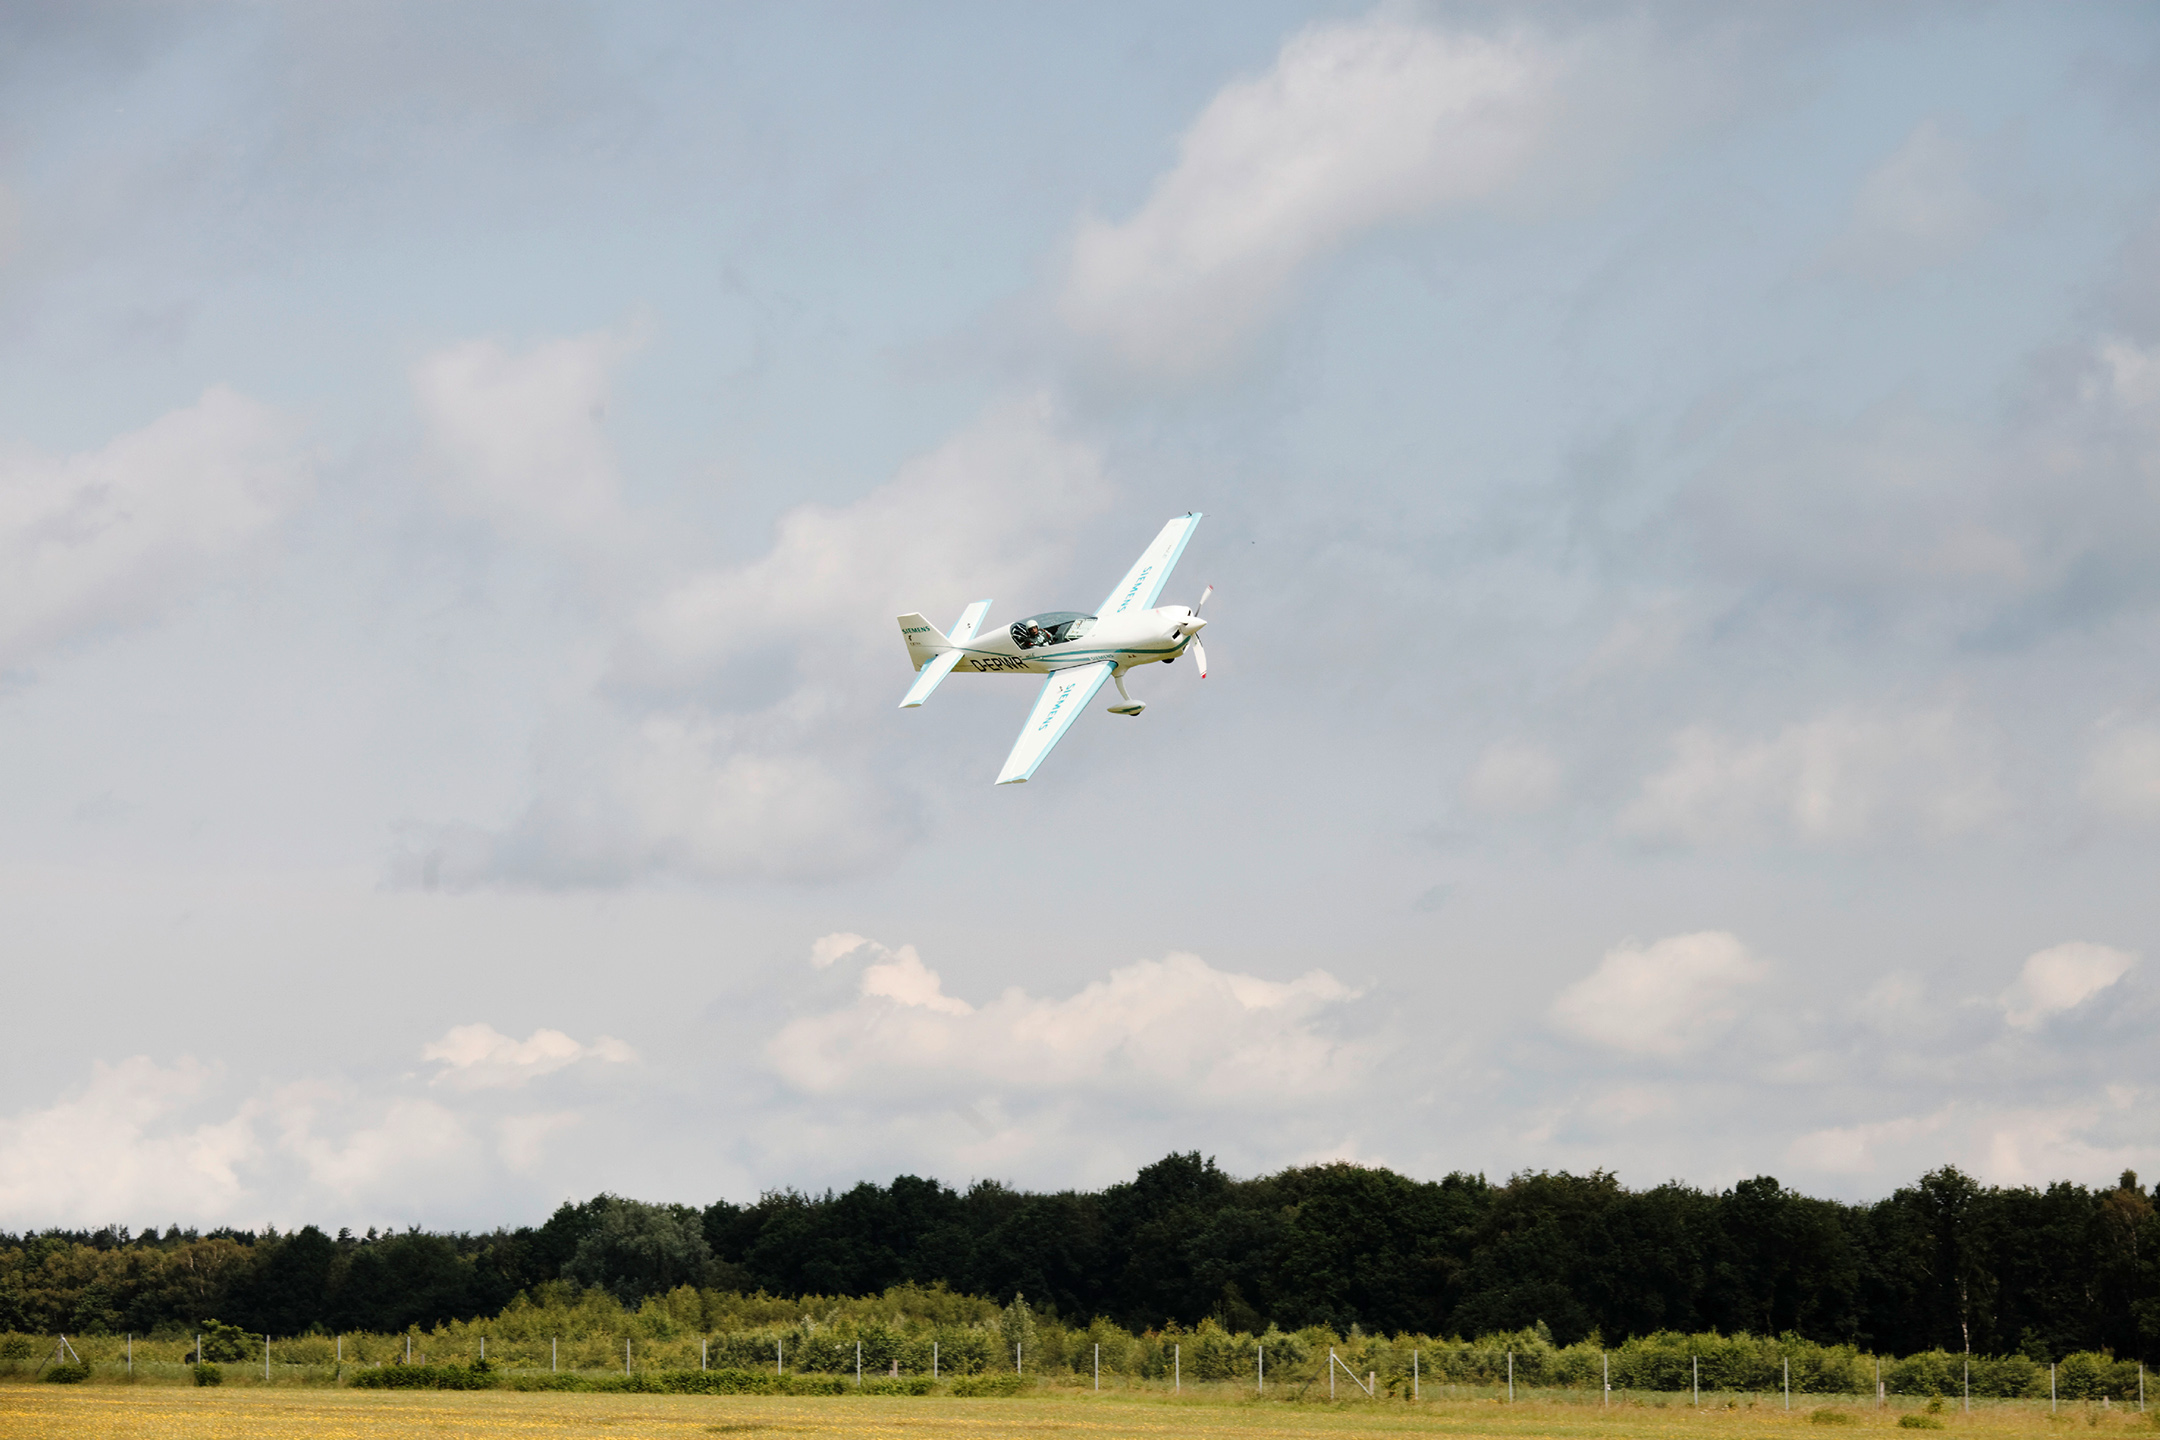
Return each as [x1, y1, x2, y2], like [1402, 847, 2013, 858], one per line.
[0, 1384, 2154, 1440]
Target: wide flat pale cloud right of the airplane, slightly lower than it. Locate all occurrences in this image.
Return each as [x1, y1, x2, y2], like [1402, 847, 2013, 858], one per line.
[1620, 710, 2007, 844]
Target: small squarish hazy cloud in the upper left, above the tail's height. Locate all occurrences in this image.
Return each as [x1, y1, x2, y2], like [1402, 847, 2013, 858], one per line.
[413, 332, 635, 546]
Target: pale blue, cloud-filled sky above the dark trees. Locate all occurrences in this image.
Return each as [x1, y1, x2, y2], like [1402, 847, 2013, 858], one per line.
[0, 0, 2160, 1228]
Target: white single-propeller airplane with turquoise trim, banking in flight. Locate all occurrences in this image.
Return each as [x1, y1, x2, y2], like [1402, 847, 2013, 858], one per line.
[901, 510, 1214, 786]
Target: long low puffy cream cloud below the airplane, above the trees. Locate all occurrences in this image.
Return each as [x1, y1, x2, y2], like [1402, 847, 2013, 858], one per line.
[767, 943, 1372, 1108]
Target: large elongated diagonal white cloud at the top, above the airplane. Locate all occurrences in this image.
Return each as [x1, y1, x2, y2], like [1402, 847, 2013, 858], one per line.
[1058, 11, 1566, 376]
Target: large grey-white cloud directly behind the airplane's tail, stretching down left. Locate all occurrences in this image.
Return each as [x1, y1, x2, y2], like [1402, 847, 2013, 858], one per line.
[408, 397, 1114, 887]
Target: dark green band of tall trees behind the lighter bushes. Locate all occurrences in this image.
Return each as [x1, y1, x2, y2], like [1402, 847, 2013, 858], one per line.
[0, 1153, 2160, 1362]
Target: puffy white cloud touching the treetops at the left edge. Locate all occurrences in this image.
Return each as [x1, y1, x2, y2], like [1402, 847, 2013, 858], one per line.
[0, 1056, 259, 1226]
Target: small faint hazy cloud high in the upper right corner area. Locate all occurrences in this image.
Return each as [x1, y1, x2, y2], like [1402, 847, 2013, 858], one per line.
[1825, 119, 2002, 283]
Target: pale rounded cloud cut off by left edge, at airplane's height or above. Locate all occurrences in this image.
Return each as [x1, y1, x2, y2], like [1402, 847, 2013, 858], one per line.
[0, 384, 309, 669]
